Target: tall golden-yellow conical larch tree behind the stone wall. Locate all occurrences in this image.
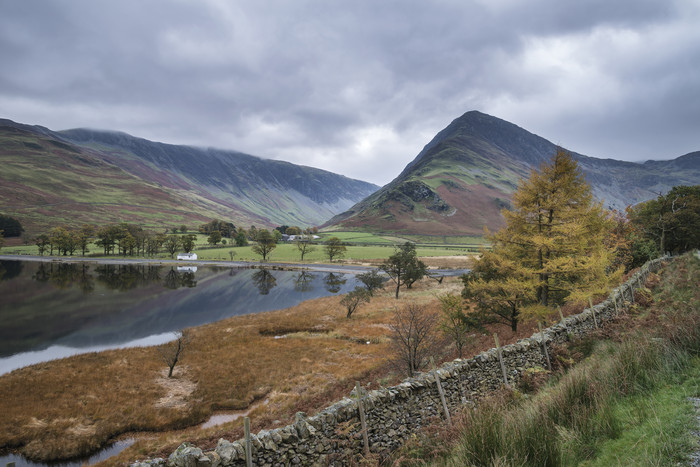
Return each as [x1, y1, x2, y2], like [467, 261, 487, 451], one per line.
[464, 148, 622, 330]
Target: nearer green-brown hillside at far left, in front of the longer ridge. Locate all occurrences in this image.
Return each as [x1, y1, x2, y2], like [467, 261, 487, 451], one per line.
[0, 128, 221, 236]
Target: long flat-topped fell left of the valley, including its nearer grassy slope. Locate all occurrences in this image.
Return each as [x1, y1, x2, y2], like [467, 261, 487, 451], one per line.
[0, 119, 379, 235]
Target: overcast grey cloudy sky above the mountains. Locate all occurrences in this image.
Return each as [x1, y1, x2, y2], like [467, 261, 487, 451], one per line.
[0, 0, 700, 185]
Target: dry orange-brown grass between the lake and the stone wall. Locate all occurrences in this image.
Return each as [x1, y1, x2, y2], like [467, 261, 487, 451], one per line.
[0, 266, 584, 465]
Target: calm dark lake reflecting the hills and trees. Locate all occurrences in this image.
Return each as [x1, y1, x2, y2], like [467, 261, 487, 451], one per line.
[0, 261, 357, 374]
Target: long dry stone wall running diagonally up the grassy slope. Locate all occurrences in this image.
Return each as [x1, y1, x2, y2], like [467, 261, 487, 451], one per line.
[132, 257, 668, 467]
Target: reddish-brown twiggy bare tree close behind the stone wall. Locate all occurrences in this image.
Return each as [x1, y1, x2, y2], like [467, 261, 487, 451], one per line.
[389, 304, 439, 377]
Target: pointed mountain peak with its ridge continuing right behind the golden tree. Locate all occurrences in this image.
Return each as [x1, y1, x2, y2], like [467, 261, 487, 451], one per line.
[326, 111, 700, 235]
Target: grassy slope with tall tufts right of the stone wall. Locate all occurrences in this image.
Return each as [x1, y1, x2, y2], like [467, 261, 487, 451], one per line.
[397, 256, 700, 466]
